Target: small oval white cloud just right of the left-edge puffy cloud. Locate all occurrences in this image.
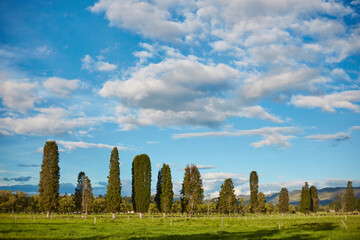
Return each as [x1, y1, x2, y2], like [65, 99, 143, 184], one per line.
[43, 77, 80, 98]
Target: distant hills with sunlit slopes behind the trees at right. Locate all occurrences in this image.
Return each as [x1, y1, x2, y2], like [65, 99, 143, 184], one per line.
[238, 187, 360, 206]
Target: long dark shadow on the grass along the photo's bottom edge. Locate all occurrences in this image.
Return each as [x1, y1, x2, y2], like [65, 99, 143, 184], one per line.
[129, 229, 318, 240]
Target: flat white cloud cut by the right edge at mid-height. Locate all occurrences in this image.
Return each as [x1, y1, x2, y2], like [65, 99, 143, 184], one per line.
[291, 90, 360, 112]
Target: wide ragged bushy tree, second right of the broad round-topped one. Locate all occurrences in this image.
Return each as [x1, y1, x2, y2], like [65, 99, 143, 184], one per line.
[180, 165, 204, 217]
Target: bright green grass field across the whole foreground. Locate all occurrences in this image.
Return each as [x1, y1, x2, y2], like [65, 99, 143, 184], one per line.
[0, 214, 360, 240]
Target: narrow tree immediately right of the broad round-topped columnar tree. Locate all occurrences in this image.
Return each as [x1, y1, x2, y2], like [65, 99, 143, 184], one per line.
[160, 164, 174, 217]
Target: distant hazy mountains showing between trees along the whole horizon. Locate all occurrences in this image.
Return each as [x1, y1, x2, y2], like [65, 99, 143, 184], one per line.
[0, 183, 360, 205]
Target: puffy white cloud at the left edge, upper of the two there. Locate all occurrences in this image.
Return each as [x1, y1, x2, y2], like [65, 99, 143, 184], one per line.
[0, 81, 40, 113]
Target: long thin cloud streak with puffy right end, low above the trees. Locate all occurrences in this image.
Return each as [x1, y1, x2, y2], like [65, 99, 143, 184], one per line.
[173, 127, 300, 148]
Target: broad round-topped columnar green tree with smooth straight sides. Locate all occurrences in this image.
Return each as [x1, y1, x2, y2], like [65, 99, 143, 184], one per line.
[132, 154, 151, 218]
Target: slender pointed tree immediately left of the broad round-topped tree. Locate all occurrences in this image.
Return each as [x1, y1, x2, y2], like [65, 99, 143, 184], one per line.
[106, 147, 121, 219]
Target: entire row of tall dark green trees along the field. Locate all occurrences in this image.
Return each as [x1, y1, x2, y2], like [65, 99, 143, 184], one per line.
[31, 141, 356, 218]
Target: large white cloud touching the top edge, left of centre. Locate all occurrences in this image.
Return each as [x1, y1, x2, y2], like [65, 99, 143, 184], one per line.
[89, 0, 203, 41]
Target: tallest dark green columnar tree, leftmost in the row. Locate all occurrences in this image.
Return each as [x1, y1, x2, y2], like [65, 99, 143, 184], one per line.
[38, 141, 60, 217]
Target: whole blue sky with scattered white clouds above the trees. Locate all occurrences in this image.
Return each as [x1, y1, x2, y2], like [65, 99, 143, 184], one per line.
[0, 0, 360, 197]
